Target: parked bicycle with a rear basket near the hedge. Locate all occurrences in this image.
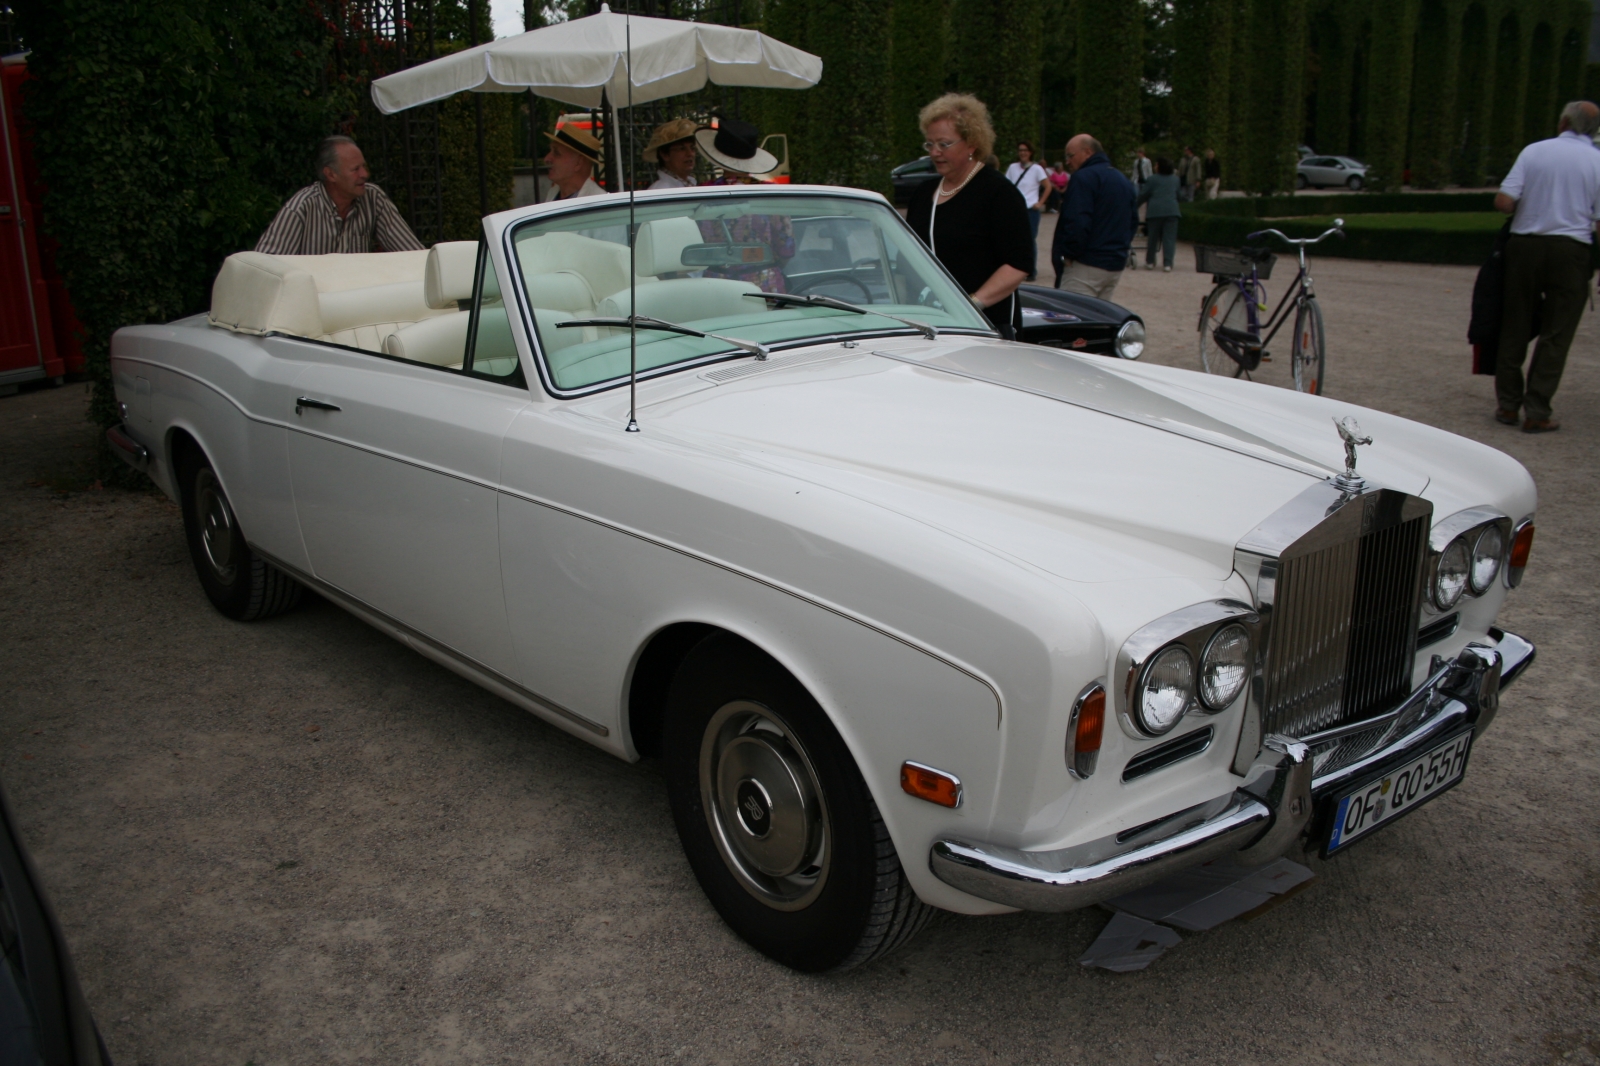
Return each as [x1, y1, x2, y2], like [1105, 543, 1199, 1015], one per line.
[1195, 218, 1344, 395]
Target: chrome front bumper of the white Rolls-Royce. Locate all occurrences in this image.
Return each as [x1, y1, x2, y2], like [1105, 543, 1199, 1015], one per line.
[928, 629, 1534, 911]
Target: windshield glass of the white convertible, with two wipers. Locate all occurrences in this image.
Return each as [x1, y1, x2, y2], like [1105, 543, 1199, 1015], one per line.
[510, 194, 990, 392]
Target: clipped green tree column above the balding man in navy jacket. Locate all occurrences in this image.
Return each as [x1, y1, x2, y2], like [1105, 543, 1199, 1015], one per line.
[1075, 0, 1144, 168]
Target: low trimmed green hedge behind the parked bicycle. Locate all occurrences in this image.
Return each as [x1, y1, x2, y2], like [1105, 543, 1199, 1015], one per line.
[1178, 208, 1506, 266]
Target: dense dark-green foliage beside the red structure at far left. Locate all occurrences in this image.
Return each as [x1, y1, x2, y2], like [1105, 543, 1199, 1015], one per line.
[18, 0, 339, 438]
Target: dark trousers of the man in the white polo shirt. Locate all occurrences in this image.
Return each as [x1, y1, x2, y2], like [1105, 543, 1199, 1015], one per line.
[1494, 234, 1589, 419]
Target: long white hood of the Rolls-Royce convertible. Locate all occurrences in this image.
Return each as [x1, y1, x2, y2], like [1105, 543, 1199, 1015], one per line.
[611, 338, 1427, 581]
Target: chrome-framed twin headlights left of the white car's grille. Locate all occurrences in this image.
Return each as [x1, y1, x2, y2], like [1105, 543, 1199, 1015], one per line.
[1117, 600, 1258, 736]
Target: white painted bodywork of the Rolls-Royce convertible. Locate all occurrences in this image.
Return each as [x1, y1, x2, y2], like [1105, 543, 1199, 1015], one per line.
[112, 189, 1536, 914]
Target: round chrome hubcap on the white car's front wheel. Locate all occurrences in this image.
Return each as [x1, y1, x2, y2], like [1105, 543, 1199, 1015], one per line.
[699, 699, 830, 911]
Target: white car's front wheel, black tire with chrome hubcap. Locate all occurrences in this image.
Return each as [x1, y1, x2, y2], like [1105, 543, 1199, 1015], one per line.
[662, 634, 938, 973]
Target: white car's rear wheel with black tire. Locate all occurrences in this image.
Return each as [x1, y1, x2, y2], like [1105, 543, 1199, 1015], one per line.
[178, 450, 304, 621]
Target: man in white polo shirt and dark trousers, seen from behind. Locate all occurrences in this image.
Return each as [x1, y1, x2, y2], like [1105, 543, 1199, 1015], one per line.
[1494, 101, 1600, 434]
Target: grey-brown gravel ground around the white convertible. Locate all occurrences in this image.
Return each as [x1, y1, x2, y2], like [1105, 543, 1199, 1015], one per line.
[0, 235, 1600, 1066]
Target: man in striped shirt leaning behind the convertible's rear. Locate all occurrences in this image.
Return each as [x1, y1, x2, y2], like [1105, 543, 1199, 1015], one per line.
[256, 136, 422, 256]
